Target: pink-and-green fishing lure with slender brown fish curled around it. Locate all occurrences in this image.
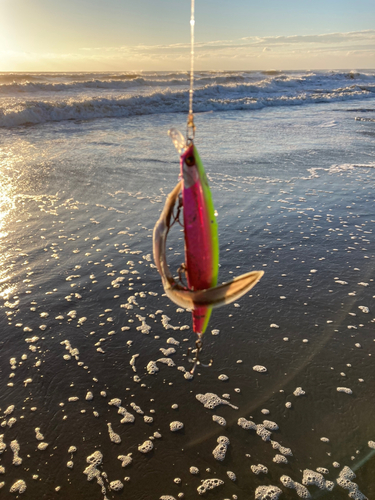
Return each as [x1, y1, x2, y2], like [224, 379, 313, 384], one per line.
[153, 129, 264, 338]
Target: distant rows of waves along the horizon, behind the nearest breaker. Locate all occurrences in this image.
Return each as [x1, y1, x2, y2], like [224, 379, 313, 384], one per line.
[0, 71, 375, 97]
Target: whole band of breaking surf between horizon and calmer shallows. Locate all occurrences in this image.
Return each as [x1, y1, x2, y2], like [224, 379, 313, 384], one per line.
[0, 70, 375, 127]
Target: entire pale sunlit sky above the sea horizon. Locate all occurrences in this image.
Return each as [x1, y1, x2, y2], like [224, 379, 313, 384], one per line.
[0, 0, 375, 72]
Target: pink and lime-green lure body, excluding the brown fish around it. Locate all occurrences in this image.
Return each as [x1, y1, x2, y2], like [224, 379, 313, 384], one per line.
[180, 145, 219, 334]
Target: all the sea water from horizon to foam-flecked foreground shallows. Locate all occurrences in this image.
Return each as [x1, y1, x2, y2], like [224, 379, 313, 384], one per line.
[0, 70, 375, 500]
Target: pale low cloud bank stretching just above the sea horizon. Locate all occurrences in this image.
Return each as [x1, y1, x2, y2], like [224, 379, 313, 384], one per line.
[0, 30, 375, 71]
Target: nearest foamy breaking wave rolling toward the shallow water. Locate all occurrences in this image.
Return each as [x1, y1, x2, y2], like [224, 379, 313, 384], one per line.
[0, 81, 374, 127]
